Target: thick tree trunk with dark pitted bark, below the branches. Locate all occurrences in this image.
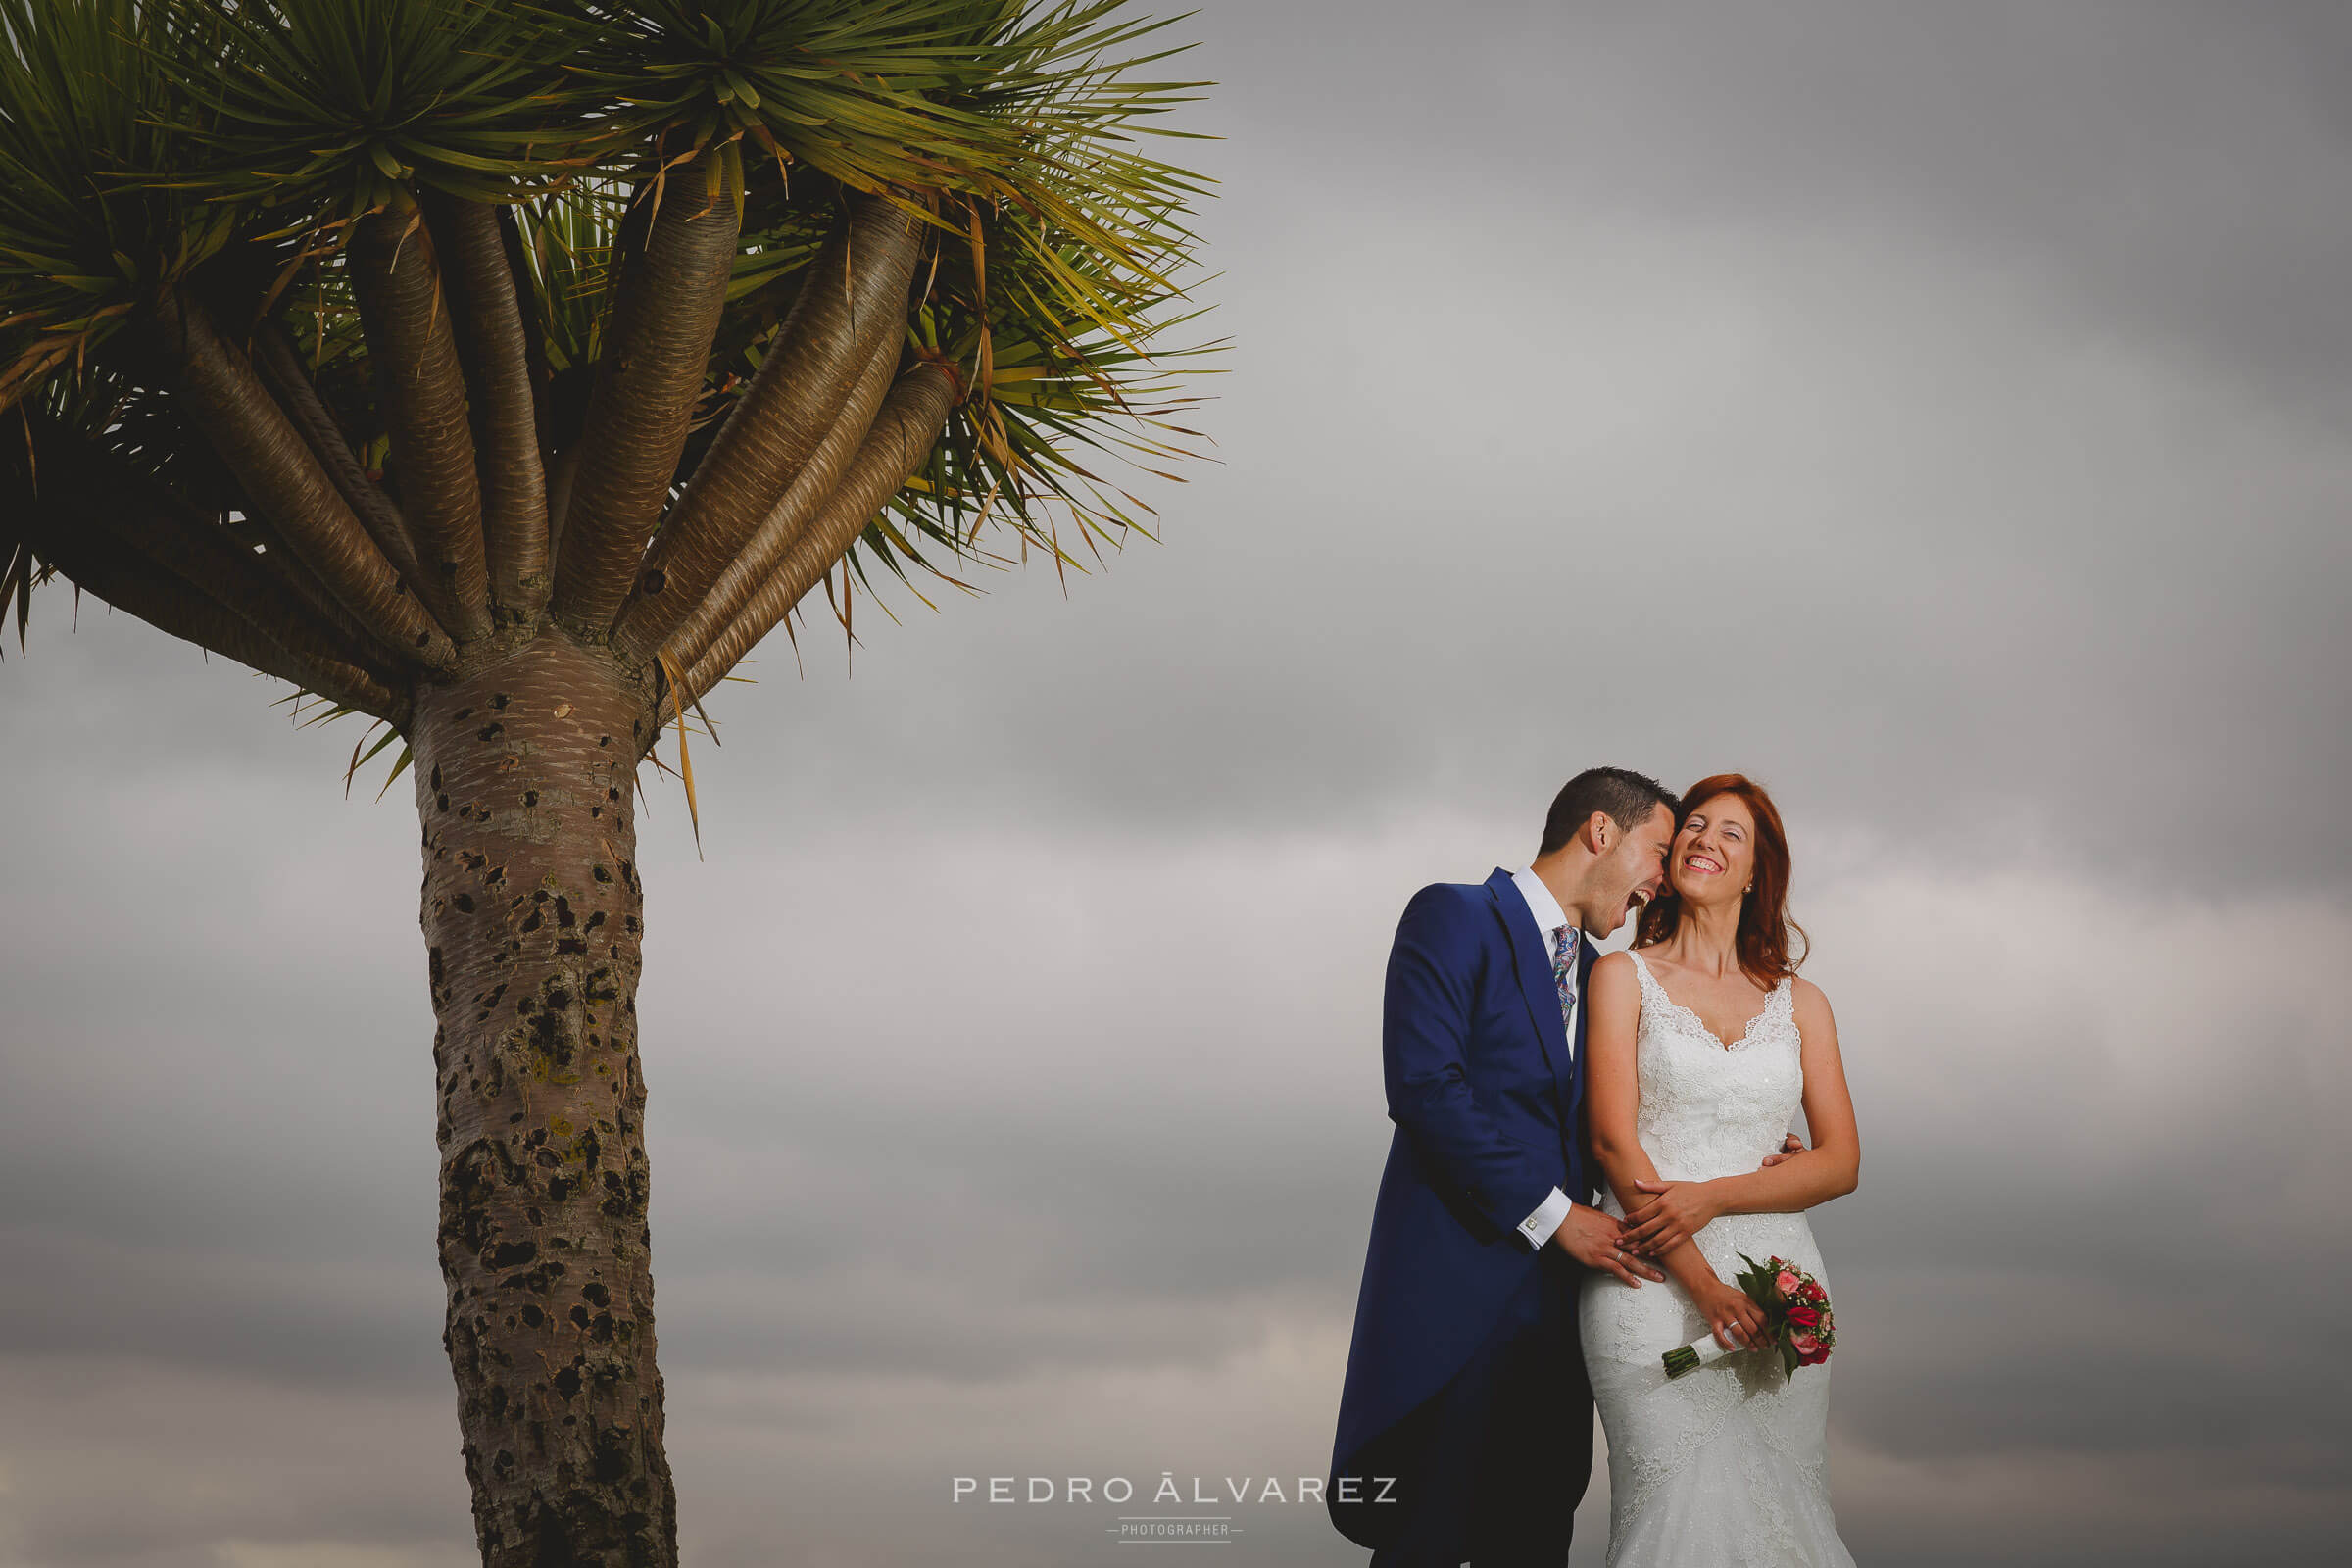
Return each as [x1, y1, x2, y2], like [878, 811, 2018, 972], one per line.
[410, 625, 677, 1568]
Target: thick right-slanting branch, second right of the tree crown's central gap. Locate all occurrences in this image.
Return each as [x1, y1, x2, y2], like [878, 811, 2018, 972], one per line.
[613, 193, 922, 656]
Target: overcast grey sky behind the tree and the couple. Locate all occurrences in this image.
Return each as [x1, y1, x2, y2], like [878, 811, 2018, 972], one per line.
[0, 0, 2352, 1568]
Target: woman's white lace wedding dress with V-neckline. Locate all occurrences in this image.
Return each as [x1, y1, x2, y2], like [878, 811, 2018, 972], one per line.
[1578, 953, 1853, 1568]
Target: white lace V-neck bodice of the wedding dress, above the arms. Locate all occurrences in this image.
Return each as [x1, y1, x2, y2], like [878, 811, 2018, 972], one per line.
[1630, 953, 1804, 1180]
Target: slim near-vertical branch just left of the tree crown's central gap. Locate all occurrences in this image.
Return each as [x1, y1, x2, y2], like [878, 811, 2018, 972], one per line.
[430, 197, 551, 620]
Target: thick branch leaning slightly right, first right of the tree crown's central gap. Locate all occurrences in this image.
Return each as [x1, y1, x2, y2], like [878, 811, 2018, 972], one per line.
[553, 151, 739, 642]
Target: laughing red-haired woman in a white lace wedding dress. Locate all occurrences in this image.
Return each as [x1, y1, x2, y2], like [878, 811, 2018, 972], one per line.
[1578, 773, 1860, 1568]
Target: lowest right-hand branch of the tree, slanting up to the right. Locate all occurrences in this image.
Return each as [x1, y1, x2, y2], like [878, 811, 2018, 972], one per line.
[654, 360, 955, 724]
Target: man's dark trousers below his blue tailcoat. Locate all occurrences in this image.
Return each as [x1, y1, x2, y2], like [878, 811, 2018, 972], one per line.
[1354, 1246, 1592, 1568]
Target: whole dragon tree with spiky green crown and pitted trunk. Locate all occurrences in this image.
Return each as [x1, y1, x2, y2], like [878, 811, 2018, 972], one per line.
[0, 0, 1213, 1568]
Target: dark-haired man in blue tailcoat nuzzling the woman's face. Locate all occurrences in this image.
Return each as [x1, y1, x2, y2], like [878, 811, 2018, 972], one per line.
[1324, 768, 1675, 1568]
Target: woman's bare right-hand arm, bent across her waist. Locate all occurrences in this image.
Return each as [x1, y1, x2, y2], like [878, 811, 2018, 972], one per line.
[1618, 968, 1863, 1260]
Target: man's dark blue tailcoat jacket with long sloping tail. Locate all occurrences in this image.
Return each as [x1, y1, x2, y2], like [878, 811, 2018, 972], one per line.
[1331, 870, 1597, 1513]
